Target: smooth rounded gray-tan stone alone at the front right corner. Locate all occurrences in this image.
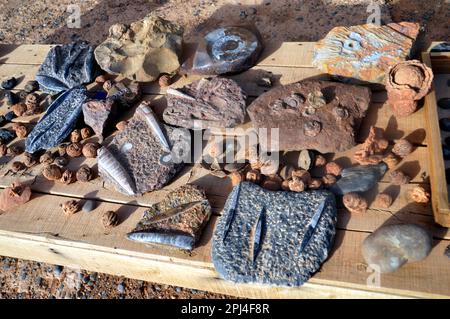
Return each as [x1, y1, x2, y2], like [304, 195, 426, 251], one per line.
[362, 224, 433, 273]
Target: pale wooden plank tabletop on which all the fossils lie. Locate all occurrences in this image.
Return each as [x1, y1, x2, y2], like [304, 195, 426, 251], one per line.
[0, 43, 450, 298]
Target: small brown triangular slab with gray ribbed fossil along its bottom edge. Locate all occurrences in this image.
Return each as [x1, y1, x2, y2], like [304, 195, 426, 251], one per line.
[127, 184, 211, 250]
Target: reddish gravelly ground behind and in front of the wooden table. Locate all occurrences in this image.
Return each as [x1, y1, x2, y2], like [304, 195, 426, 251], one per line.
[0, 0, 450, 298]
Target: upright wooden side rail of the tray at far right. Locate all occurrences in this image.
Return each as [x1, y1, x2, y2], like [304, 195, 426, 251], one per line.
[422, 53, 450, 227]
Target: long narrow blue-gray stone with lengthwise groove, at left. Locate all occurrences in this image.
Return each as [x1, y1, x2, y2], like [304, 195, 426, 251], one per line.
[25, 86, 87, 153]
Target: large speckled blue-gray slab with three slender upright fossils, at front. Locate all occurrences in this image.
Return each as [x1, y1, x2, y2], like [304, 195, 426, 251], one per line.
[212, 182, 337, 286]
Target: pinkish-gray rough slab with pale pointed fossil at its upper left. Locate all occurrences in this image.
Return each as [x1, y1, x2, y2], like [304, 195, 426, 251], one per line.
[163, 77, 246, 129]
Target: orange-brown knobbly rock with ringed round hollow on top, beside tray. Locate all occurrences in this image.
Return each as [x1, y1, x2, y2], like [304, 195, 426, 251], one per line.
[386, 60, 433, 117]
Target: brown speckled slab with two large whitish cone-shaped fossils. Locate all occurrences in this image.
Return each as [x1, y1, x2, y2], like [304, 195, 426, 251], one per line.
[98, 102, 183, 196]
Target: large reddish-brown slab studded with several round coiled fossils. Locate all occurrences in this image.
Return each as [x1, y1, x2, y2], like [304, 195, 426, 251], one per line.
[247, 80, 371, 153]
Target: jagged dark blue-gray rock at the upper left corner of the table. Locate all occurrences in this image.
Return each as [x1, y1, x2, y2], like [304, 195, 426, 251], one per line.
[36, 42, 98, 93]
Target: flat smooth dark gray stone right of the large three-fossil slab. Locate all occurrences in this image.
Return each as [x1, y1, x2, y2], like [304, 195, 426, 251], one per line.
[330, 162, 387, 195]
